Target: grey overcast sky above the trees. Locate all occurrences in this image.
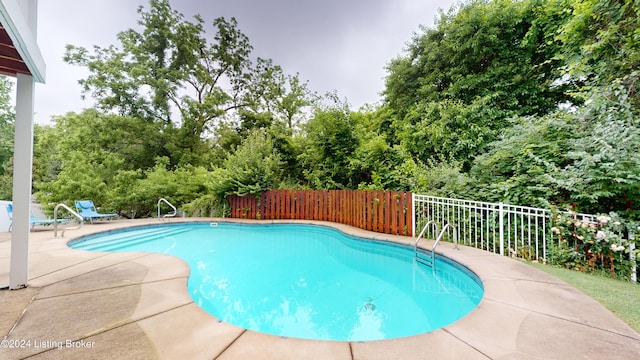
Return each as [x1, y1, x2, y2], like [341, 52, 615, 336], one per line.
[35, 0, 456, 124]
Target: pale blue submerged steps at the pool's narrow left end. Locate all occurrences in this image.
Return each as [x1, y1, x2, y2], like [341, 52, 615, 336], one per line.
[72, 227, 189, 251]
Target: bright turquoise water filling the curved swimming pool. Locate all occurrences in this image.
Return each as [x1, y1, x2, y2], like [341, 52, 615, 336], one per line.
[69, 223, 483, 341]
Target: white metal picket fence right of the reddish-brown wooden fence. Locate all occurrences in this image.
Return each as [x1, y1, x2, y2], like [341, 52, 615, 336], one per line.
[413, 194, 596, 260]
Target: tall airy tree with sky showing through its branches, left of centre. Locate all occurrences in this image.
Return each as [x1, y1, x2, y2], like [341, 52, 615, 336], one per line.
[65, 0, 313, 166]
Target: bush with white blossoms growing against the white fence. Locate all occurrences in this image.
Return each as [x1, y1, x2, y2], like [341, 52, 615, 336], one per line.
[548, 208, 638, 278]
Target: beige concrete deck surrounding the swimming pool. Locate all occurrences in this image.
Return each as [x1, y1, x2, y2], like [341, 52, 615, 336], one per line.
[0, 219, 640, 359]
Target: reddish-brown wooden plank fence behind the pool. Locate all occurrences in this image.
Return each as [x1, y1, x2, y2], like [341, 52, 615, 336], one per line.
[227, 190, 413, 235]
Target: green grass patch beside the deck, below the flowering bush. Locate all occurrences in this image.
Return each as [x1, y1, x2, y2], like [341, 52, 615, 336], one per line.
[529, 263, 640, 333]
